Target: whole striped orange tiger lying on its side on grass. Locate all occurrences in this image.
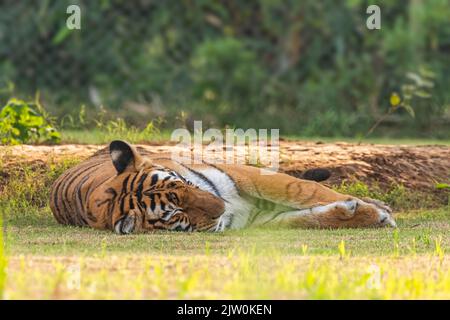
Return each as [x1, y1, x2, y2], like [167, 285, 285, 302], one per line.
[50, 140, 396, 234]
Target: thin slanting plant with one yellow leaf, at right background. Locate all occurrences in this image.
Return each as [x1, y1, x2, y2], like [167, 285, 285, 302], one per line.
[360, 68, 435, 142]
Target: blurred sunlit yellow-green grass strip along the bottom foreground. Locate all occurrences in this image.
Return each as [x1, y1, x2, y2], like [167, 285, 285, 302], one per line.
[5, 250, 450, 299]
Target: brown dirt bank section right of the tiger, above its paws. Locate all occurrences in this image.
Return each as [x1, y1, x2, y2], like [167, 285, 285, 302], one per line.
[281, 143, 450, 191]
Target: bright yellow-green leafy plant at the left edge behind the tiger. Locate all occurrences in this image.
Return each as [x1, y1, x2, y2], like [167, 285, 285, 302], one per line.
[0, 96, 61, 145]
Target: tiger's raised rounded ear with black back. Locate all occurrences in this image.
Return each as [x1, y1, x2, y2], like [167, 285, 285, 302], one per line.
[109, 140, 149, 174]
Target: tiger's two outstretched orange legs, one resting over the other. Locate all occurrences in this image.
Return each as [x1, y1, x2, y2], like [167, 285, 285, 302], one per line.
[223, 166, 395, 228]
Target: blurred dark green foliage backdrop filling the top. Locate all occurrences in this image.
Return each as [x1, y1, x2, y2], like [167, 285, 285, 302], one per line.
[0, 0, 450, 138]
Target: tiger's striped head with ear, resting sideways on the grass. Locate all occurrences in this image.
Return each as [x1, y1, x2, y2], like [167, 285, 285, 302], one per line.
[104, 140, 225, 234]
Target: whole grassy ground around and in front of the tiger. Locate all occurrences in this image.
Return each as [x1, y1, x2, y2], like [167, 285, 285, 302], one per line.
[0, 161, 450, 299]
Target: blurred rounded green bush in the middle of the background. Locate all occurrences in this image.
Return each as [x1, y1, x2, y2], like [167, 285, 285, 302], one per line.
[191, 37, 267, 122]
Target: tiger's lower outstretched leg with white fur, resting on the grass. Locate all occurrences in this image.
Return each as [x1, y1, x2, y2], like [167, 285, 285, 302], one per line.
[277, 199, 396, 229]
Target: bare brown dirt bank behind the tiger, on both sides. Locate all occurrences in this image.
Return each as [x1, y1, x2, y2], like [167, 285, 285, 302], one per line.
[0, 141, 450, 199]
